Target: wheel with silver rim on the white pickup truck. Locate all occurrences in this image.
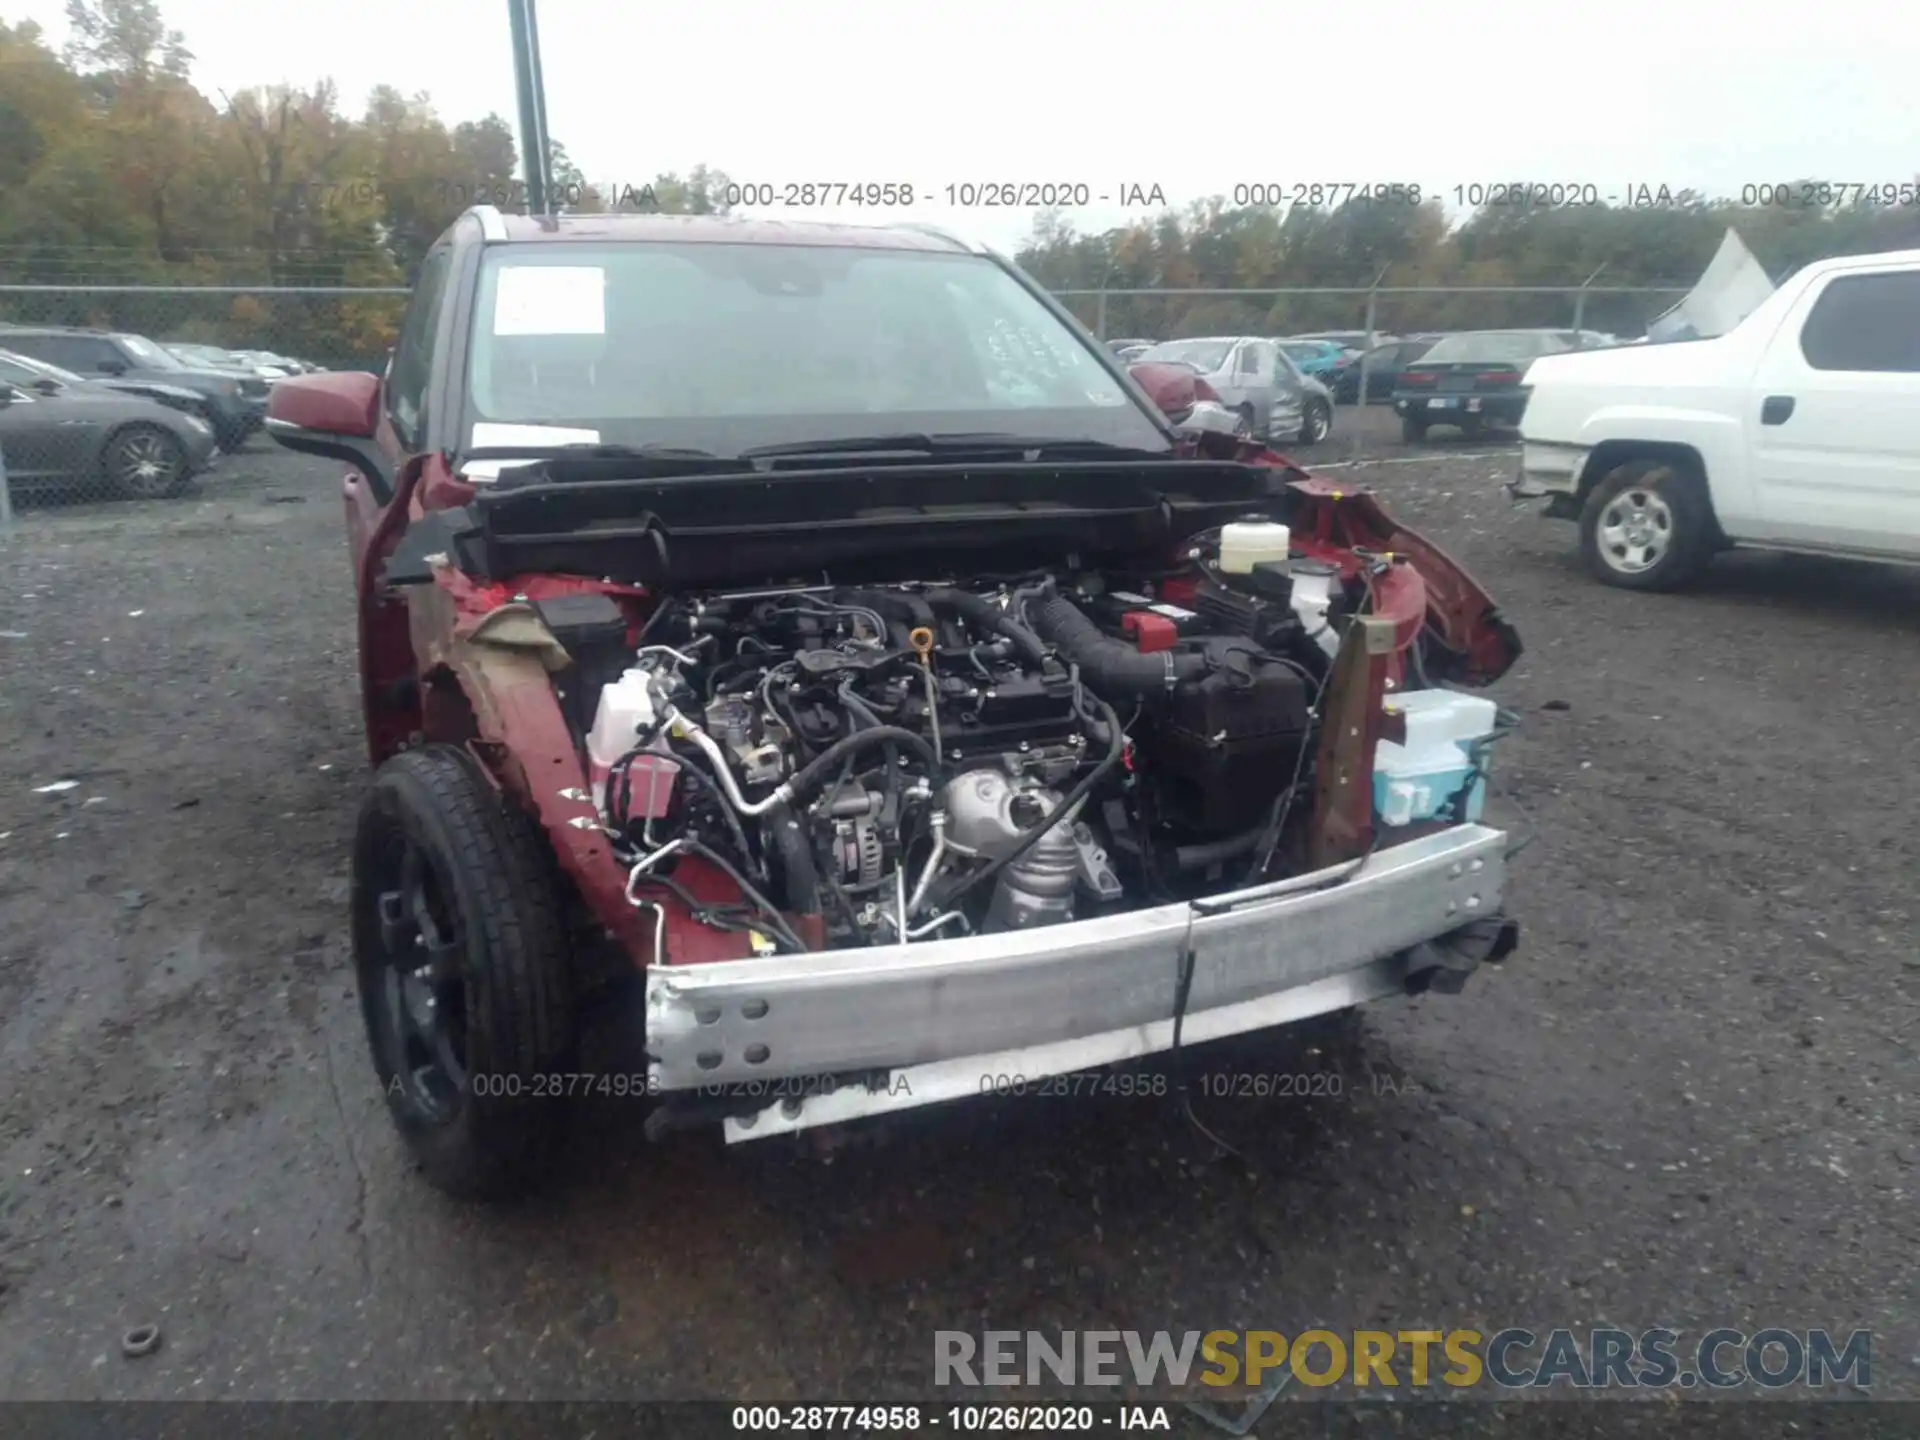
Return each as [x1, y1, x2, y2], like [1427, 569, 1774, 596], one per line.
[1580, 459, 1715, 589]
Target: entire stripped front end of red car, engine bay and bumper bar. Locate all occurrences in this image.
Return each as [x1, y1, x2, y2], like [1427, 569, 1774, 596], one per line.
[390, 449, 1519, 1140]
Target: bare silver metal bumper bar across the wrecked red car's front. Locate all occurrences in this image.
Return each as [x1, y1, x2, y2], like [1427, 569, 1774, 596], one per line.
[647, 824, 1507, 1140]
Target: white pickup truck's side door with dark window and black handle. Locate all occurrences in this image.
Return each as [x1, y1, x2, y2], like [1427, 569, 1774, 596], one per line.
[1745, 267, 1920, 557]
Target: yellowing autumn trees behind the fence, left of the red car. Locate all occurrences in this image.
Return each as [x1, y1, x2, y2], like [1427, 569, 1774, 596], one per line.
[0, 0, 726, 363]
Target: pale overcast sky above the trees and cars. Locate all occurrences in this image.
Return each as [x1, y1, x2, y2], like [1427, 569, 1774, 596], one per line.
[0, 0, 1920, 248]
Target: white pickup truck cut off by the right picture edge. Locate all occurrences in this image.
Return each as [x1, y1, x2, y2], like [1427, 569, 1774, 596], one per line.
[1509, 250, 1920, 589]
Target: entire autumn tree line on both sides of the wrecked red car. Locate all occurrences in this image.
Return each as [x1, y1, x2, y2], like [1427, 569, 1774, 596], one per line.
[0, 0, 1920, 365]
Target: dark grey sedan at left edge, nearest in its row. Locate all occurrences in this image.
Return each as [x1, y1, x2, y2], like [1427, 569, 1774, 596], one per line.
[0, 380, 217, 499]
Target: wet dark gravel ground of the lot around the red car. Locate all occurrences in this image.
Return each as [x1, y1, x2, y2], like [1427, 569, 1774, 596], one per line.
[0, 420, 1920, 1400]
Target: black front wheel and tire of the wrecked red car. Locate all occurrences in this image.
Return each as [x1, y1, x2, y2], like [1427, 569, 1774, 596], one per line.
[351, 745, 578, 1200]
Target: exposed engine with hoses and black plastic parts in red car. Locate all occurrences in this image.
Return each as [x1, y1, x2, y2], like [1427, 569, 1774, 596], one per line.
[578, 526, 1367, 952]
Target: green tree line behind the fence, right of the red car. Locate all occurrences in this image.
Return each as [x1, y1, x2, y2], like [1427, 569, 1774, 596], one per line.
[1020, 180, 1920, 338]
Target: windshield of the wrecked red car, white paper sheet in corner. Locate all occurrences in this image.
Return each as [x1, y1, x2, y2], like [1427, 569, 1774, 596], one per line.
[467, 244, 1169, 455]
